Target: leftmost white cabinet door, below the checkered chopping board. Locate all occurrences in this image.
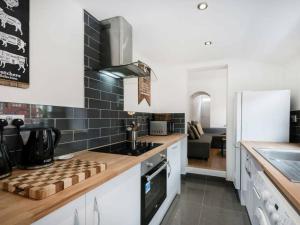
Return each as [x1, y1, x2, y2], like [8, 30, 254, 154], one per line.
[32, 196, 85, 225]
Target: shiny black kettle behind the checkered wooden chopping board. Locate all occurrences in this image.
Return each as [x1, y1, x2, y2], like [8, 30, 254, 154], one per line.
[17, 123, 61, 169]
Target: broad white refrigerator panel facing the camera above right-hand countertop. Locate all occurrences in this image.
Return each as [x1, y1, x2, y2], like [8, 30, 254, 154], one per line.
[241, 90, 290, 142]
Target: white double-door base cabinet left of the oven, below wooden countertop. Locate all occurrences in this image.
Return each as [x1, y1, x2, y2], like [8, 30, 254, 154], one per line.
[32, 164, 141, 225]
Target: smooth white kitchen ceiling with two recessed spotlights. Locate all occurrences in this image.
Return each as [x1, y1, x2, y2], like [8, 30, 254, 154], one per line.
[77, 0, 300, 64]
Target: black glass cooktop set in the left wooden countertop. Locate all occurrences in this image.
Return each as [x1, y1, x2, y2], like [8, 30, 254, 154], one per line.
[90, 141, 162, 156]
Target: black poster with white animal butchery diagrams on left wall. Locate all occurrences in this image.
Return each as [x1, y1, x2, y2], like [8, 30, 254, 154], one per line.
[0, 0, 29, 88]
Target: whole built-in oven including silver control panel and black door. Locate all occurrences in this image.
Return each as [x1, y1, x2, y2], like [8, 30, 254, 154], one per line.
[141, 150, 168, 225]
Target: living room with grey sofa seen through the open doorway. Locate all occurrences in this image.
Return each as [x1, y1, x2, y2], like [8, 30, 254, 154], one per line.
[187, 66, 227, 176]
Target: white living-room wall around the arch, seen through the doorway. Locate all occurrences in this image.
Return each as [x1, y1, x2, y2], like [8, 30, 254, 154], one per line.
[187, 68, 227, 127]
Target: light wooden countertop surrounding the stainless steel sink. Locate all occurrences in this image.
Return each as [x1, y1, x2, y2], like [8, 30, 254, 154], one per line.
[241, 141, 300, 213]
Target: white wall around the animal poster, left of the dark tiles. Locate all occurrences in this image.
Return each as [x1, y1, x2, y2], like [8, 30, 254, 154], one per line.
[0, 0, 84, 107]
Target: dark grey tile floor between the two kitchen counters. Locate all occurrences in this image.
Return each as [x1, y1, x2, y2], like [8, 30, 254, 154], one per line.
[161, 174, 250, 225]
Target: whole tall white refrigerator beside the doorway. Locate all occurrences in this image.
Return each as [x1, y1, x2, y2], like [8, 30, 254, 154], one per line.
[234, 90, 291, 193]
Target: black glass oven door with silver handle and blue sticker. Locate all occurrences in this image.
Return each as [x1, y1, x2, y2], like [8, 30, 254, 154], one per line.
[141, 161, 168, 225]
